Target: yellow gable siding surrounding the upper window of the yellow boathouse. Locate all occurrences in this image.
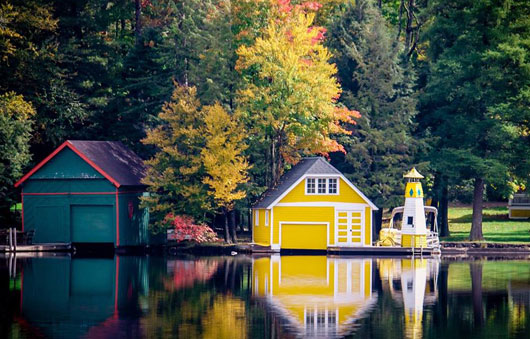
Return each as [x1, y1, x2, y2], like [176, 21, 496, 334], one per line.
[280, 179, 366, 204]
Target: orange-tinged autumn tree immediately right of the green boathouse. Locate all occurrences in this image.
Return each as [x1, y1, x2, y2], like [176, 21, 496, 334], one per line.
[142, 83, 212, 230]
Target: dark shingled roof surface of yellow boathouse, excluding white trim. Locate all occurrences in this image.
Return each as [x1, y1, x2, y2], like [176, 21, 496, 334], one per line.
[254, 157, 341, 208]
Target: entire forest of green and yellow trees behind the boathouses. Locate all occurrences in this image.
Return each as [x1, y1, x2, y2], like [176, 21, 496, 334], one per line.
[0, 0, 530, 240]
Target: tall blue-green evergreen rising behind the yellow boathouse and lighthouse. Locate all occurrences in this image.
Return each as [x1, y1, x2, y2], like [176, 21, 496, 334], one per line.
[328, 0, 418, 207]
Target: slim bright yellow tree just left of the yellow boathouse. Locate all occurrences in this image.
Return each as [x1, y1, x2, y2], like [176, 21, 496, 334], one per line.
[201, 103, 249, 242]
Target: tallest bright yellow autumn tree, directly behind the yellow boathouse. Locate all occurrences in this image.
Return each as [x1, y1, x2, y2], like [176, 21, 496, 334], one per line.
[236, 1, 357, 185]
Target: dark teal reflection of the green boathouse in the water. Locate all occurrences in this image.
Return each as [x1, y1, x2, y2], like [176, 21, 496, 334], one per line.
[19, 256, 149, 338]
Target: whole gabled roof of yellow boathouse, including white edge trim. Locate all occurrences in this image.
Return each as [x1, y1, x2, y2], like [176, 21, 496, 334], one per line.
[253, 157, 378, 210]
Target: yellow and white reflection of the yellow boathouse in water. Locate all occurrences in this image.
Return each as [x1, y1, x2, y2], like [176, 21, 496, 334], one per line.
[252, 255, 377, 337]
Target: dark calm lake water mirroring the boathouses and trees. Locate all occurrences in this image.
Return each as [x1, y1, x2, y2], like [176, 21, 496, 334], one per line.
[0, 255, 530, 339]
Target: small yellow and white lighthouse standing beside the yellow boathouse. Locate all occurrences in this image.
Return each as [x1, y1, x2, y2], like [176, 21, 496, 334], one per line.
[401, 168, 427, 247]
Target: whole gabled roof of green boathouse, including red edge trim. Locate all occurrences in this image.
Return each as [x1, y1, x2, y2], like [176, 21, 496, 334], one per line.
[15, 140, 146, 187]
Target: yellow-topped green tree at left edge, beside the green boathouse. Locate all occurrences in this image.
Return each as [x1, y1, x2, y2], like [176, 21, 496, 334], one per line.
[0, 92, 35, 225]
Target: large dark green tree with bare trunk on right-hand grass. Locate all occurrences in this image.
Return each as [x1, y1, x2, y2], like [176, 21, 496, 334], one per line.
[421, 0, 529, 240]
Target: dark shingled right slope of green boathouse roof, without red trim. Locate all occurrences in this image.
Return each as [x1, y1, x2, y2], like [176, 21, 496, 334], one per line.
[68, 140, 146, 186]
